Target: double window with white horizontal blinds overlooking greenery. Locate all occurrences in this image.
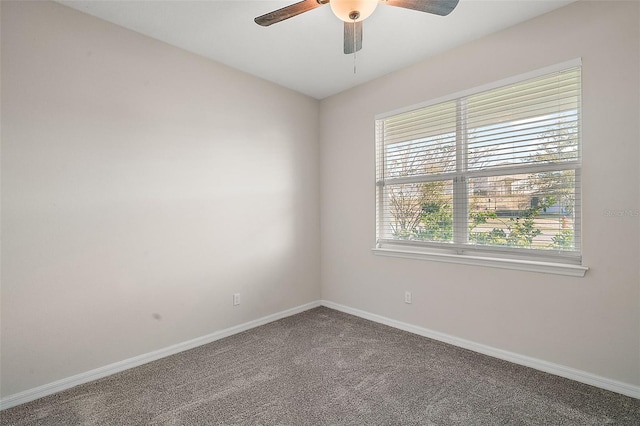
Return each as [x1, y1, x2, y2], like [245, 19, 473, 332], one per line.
[376, 61, 586, 275]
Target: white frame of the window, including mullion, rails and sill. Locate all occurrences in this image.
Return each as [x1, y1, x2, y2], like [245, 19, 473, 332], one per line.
[372, 58, 588, 277]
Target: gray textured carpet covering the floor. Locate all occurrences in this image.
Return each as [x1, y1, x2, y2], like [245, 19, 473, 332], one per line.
[0, 307, 640, 426]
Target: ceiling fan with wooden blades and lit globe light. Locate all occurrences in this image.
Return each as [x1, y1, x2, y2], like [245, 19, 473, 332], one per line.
[255, 0, 459, 55]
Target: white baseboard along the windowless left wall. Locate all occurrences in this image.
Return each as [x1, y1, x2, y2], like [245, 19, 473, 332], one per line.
[0, 301, 320, 411]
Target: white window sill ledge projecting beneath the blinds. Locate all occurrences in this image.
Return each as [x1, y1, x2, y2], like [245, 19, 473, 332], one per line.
[371, 248, 589, 277]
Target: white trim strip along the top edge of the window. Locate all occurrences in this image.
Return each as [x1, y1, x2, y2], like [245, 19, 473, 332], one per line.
[374, 58, 582, 120]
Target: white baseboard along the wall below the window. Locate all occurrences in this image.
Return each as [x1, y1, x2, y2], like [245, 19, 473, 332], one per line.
[321, 300, 640, 399]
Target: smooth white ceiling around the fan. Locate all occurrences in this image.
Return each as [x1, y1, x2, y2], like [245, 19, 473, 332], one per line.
[57, 0, 575, 99]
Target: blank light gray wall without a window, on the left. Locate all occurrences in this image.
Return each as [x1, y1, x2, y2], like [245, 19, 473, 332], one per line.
[0, 1, 320, 396]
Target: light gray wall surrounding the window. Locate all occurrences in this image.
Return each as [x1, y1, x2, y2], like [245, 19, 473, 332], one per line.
[320, 1, 640, 385]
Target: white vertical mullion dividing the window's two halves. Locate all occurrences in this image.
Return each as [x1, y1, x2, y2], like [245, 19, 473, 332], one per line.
[453, 98, 469, 244]
